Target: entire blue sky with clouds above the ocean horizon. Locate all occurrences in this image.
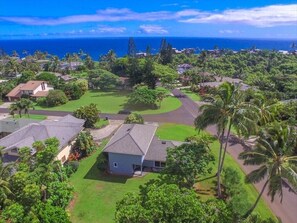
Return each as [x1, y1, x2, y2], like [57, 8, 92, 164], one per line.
[0, 0, 297, 39]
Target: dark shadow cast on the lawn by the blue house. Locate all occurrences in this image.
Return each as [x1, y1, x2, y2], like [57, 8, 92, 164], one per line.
[84, 159, 131, 184]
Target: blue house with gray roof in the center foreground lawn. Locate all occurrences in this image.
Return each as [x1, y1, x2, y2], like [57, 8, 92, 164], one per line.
[104, 124, 182, 175]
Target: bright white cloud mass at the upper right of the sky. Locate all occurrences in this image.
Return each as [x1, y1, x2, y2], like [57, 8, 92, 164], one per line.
[180, 4, 297, 27]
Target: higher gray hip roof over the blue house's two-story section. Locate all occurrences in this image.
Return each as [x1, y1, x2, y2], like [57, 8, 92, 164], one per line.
[104, 124, 157, 156]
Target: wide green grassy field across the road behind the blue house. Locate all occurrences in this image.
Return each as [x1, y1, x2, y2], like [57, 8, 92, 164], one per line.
[35, 91, 181, 114]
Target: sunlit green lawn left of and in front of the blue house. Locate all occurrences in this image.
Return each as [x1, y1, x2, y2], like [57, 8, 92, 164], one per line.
[69, 141, 158, 223]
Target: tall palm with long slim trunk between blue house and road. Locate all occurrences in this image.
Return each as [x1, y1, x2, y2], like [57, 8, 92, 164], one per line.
[195, 82, 256, 197]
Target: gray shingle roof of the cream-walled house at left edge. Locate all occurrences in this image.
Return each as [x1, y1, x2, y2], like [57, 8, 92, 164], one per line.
[0, 116, 84, 151]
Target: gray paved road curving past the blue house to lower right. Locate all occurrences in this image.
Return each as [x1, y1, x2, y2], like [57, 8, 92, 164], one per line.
[0, 89, 297, 223]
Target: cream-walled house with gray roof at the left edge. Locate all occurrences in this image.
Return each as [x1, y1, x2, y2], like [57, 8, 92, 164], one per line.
[0, 115, 85, 163]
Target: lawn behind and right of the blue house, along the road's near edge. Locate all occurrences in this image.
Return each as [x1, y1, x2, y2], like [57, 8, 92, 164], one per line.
[156, 124, 275, 218]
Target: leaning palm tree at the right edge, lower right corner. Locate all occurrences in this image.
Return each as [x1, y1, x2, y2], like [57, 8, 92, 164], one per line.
[239, 122, 297, 218]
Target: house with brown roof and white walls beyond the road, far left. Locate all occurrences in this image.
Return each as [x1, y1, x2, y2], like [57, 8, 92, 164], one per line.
[6, 81, 53, 101]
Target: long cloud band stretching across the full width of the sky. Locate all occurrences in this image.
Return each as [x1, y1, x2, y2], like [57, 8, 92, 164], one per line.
[0, 3, 297, 27]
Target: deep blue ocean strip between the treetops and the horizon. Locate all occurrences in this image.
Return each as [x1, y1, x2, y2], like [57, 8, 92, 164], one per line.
[0, 37, 296, 60]
